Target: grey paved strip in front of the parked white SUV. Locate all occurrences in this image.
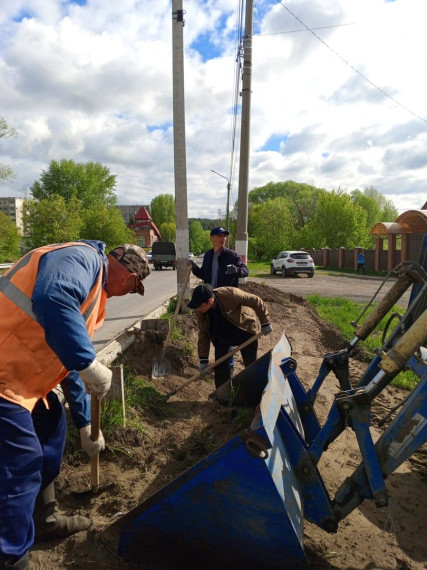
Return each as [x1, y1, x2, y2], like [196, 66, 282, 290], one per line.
[250, 271, 410, 306]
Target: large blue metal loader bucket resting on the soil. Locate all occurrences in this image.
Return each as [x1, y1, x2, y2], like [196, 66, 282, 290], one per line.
[109, 334, 307, 570]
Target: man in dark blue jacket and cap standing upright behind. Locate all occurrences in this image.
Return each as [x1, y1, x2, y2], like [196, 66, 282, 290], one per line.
[188, 226, 249, 376]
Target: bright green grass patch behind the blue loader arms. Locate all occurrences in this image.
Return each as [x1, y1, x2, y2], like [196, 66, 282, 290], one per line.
[307, 295, 419, 390]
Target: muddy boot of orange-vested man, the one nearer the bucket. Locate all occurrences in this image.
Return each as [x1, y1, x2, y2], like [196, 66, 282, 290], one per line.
[34, 482, 92, 540]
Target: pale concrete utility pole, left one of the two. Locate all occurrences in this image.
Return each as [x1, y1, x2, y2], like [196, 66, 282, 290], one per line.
[172, 0, 190, 300]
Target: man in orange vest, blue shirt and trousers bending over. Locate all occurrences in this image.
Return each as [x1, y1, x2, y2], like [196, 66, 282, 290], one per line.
[0, 240, 150, 570]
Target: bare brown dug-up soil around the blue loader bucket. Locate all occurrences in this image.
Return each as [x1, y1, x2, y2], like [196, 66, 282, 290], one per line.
[31, 281, 427, 570]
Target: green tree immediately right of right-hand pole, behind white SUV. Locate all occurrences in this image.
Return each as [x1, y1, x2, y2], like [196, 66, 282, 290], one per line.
[248, 198, 295, 259]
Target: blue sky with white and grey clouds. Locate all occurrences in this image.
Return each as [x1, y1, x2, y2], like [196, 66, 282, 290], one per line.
[0, 0, 427, 221]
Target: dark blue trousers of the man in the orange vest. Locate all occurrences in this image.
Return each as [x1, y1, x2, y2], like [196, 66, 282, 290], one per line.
[0, 392, 67, 563]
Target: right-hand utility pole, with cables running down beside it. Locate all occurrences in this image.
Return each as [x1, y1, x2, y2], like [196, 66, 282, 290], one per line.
[236, 0, 254, 263]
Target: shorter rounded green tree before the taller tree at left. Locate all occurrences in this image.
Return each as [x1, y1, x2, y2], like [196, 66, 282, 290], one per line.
[23, 194, 82, 249]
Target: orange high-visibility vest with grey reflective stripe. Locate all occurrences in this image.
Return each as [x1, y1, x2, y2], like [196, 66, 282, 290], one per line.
[0, 242, 107, 412]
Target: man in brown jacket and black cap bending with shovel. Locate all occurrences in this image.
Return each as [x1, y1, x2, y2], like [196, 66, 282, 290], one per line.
[188, 284, 273, 388]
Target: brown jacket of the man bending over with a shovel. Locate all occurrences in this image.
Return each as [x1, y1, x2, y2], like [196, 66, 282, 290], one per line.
[195, 287, 269, 358]
